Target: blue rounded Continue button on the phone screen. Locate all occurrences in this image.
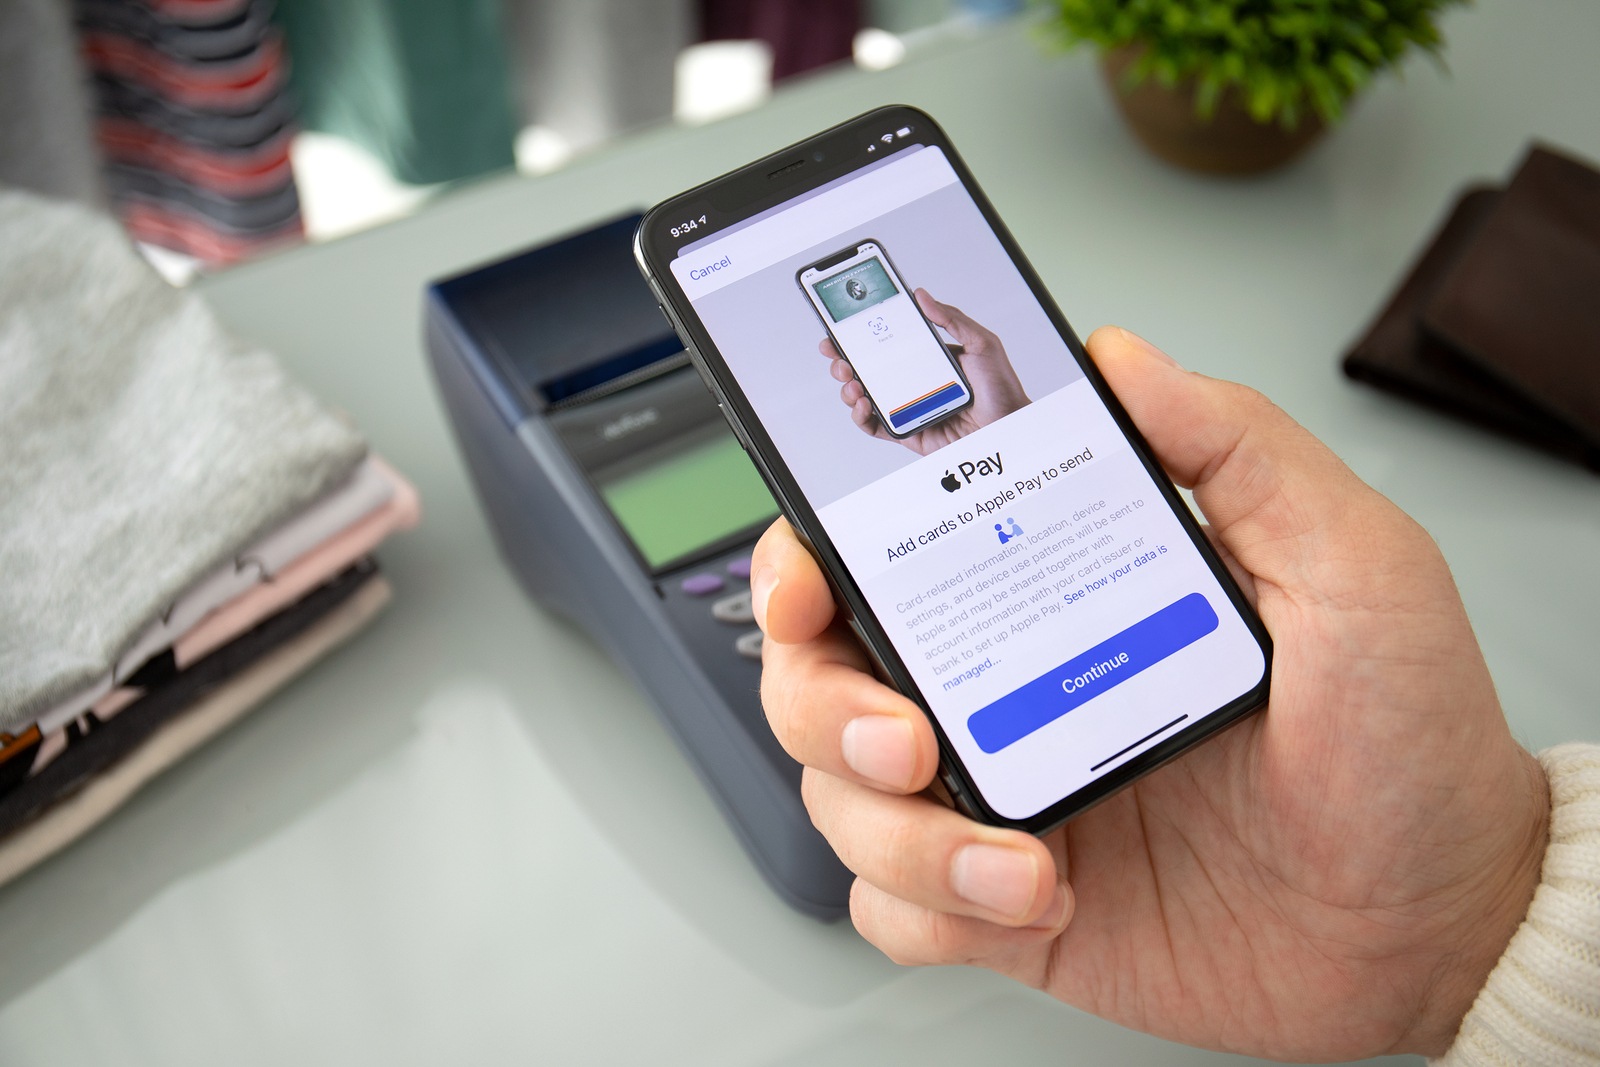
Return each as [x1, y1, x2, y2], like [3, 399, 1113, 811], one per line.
[966, 593, 1218, 752]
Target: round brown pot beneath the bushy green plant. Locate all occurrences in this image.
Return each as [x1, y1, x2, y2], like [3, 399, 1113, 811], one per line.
[1101, 48, 1326, 174]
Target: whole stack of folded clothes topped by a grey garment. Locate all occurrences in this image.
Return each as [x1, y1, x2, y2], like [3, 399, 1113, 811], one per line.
[0, 190, 418, 883]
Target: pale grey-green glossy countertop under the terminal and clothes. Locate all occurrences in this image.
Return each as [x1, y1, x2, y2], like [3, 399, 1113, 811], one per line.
[0, 0, 1600, 1067]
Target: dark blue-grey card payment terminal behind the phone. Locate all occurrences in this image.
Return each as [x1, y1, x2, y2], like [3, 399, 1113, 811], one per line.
[426, 216, 851, 918]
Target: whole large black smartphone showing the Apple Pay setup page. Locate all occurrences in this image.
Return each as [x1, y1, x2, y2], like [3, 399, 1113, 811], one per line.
[634, 107, 1272, 833]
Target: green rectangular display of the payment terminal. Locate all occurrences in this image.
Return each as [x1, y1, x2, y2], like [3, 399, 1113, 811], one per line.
[597, 434, 778, 571]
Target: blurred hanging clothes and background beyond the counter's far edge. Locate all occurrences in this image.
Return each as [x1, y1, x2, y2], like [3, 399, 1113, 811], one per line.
[0, 0, 1024, 282]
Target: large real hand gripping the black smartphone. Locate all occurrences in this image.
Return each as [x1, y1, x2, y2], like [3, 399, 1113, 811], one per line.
[752, 330, 1549, 1059]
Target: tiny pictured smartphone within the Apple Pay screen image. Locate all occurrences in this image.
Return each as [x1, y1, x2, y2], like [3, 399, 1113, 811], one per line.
[797, 240, 973, 437]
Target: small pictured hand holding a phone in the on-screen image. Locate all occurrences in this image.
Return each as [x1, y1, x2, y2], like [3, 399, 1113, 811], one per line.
[818, 290, 1029, 456]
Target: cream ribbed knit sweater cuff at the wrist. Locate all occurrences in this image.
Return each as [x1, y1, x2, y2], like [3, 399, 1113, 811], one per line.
[1434, 744, 1600, 1067]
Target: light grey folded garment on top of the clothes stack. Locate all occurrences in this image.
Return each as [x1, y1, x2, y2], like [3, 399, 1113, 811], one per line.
[0, 190, 366, 733]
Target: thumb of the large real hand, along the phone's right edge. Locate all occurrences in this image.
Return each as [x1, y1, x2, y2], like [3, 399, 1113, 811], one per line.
[1088, 326, 1410, 587]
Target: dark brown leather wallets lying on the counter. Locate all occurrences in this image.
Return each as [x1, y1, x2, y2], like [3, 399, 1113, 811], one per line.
[1344, 147, 1600, 470]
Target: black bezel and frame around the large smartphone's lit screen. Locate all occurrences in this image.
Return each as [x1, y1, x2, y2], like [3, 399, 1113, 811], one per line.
[634, 104, 1272, 833]
